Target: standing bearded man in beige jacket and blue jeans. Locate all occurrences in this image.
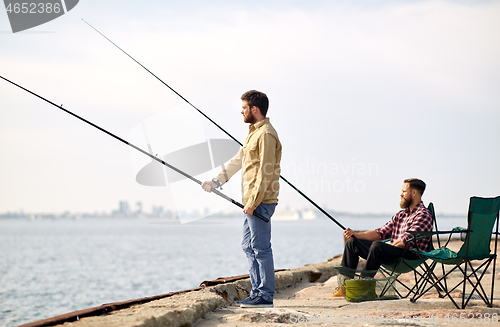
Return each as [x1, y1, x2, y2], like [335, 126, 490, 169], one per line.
[201, 90, 281, 308]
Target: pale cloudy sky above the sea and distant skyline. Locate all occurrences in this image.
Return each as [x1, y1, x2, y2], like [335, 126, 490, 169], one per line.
[0, 0, 500, 215]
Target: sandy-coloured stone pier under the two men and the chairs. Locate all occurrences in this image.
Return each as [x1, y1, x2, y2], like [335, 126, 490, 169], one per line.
[18, 240, 500, 327]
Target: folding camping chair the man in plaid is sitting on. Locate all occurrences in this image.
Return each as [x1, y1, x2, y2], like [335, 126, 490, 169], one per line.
[380, 202, 444, 298]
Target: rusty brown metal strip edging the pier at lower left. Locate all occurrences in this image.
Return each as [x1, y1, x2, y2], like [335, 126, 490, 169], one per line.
[19, 287, 203, 327]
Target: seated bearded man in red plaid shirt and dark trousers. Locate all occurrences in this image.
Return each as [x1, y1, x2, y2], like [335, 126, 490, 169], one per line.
[334, 178, 432, 296]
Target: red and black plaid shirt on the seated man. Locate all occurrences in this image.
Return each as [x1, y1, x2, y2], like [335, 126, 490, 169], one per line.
[375, 202, 432, 251]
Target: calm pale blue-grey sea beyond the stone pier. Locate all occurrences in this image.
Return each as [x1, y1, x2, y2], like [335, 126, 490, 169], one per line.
[0, 217, 465, 326]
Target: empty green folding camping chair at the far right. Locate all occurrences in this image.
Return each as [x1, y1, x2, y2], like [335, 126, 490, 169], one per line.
[411, 196, 500, 309]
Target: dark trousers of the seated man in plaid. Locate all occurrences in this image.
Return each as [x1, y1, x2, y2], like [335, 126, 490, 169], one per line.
[341, 239, 418, 278]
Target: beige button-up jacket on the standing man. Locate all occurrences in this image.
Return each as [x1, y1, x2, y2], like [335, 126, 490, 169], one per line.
[215, 118, 281, 210]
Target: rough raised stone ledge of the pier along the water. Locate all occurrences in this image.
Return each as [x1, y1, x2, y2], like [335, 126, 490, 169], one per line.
[19, 255, 342, 327]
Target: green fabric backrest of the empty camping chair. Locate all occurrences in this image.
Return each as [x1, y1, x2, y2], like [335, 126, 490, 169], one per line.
[458, 196, 500, 259]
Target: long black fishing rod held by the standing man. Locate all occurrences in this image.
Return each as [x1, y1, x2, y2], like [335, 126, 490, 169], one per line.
[0, 76, 269, 223]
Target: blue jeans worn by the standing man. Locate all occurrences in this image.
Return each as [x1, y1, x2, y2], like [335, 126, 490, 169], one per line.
[241, 203, 276, 301]
